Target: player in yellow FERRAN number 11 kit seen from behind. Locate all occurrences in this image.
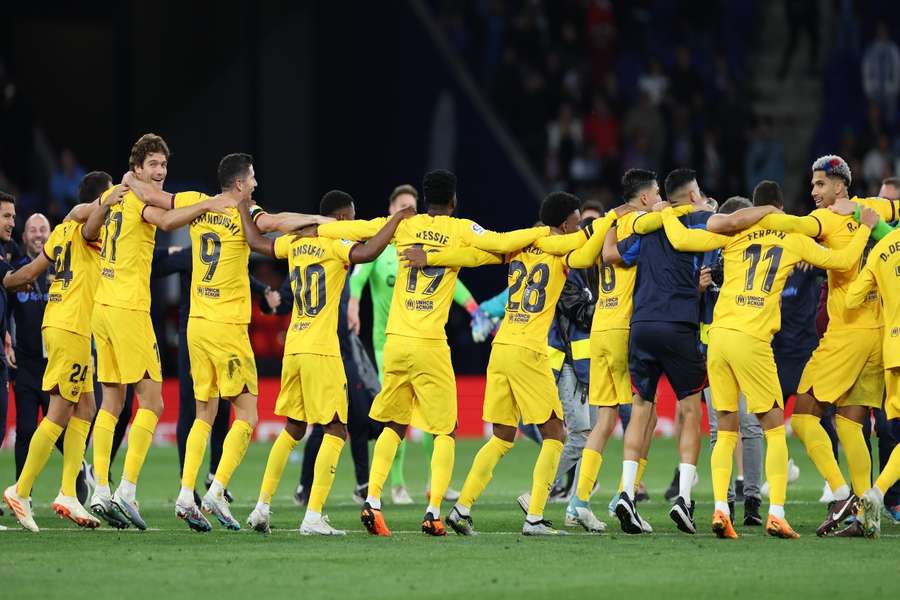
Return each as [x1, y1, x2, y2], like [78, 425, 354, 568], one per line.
[663, 181, 878, 539]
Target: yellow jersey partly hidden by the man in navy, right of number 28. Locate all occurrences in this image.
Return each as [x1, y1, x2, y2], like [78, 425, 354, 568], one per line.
[591, 212, 649, 331]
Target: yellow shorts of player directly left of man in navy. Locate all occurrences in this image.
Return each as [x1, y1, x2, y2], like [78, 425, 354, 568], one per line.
[588, 329, 634, 406]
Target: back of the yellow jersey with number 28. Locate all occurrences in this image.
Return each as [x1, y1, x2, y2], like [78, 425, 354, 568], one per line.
[494, 246, 568, 354]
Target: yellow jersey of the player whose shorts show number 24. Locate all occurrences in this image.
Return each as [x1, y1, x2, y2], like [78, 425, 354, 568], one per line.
[42, 221, 100, 337]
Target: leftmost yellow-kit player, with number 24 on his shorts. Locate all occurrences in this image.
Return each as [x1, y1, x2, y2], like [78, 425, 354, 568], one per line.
[3, 172, 127, 532]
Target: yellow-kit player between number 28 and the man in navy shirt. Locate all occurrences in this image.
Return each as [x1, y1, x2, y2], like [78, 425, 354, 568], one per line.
[566, 169, 660, 533]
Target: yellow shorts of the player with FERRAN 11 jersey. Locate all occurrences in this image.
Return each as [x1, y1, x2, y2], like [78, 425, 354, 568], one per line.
[706, 326, 784, 414]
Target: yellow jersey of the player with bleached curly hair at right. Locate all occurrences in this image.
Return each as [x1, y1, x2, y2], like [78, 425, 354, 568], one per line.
[759, 197, 900, 329]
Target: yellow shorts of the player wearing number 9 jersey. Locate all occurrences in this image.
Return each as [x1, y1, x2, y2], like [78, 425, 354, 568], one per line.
[188, 317, 259, 402]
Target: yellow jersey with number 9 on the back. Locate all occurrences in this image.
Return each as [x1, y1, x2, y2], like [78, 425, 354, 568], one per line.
[173, 192, 263, 324]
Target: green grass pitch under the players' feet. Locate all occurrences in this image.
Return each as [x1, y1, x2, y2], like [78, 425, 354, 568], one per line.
[0, 439, 900, 600]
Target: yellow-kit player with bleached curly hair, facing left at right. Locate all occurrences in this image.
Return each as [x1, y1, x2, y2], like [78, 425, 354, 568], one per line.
[711, 155, 900, 535]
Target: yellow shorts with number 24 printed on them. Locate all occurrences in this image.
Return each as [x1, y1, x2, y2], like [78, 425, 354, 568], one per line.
[41, 327, 94, 403]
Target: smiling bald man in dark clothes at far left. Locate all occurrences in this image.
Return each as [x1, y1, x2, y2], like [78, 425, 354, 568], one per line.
[7, 213, 62, 479]
